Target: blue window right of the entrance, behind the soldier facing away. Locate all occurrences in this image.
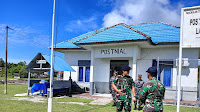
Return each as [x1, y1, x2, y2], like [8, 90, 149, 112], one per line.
[152, 59, 173, 87]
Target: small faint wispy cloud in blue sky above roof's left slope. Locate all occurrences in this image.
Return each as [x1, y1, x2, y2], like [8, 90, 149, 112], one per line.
[65, 17, 98, 32]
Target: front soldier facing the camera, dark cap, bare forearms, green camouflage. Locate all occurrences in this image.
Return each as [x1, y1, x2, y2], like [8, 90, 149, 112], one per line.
[112, 65, 136, 112]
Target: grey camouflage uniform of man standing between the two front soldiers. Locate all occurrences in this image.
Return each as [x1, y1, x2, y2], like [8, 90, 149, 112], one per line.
[134, 80, 144, 107]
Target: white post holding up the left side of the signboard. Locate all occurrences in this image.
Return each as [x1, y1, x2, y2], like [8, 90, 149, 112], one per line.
[177, 9, 183, 112]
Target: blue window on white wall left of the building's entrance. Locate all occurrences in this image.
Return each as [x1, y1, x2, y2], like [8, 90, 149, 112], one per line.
[78, 60, 90, 82]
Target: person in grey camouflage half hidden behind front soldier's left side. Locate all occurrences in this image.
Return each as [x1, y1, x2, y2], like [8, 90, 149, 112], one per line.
[109, 71, 118, 106]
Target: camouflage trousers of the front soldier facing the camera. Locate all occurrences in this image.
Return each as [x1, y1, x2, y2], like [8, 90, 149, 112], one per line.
[117, 99, 131, 112]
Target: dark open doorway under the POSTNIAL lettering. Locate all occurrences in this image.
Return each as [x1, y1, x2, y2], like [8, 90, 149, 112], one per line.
[110, 60, 129, 78]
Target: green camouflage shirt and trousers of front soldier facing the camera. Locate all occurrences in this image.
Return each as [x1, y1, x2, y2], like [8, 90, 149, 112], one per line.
[114, 75, 135, 112]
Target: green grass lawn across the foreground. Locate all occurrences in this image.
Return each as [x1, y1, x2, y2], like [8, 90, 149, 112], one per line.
[0, 84, 200, 112]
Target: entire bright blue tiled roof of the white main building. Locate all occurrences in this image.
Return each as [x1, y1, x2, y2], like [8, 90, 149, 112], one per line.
[54, 22, 180, 49]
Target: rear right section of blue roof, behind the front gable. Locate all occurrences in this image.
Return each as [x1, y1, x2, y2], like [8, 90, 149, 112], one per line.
[130, 22, 180, 43]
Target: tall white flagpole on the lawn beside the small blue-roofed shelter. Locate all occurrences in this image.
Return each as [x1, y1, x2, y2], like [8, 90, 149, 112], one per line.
[47, 0, 56, 112]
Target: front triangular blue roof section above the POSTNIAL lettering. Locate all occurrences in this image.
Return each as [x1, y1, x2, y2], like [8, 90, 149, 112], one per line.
[75, 23, 149, 44]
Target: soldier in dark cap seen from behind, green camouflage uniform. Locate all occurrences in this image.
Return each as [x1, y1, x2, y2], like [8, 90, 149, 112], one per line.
[138, 67, 165, 112]
